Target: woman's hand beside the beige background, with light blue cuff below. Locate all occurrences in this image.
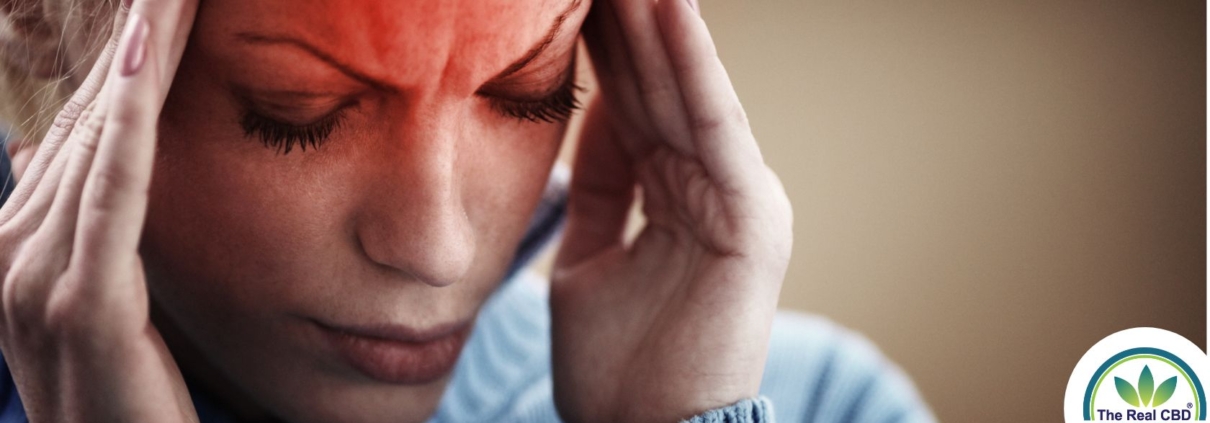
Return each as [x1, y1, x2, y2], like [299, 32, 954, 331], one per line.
[551, 0, 793, 422]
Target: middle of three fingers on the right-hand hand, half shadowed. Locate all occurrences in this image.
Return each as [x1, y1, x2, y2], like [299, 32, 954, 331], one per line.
[605, 0, 695, 153]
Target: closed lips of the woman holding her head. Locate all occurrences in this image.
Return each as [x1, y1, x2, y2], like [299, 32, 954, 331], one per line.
[316, 320, 472, 384]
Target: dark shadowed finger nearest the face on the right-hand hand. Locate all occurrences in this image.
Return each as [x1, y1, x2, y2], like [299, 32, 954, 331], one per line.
[582, 1, 657, 153]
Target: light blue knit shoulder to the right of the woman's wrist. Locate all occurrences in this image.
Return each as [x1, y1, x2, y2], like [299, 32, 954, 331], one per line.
[761, 311, 935, 423]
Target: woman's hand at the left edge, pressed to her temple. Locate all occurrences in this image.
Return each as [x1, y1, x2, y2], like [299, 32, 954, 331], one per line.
[0, 0, 197, 422]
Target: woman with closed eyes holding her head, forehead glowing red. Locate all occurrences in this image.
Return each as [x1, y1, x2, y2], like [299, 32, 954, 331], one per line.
[0, 0, 930, 422]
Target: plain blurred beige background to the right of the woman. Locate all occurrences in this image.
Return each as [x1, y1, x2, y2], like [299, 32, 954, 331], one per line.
[549, 0, 1206, 422]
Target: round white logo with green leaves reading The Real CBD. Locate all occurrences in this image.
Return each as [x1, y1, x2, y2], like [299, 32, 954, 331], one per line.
[1064, 328, 1210, 422]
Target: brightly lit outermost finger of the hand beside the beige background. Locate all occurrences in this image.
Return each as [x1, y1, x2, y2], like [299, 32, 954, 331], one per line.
[658, 0, 765, 193]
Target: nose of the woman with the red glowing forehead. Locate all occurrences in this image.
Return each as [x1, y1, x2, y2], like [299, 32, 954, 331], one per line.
[356, 117, 476, 286]
